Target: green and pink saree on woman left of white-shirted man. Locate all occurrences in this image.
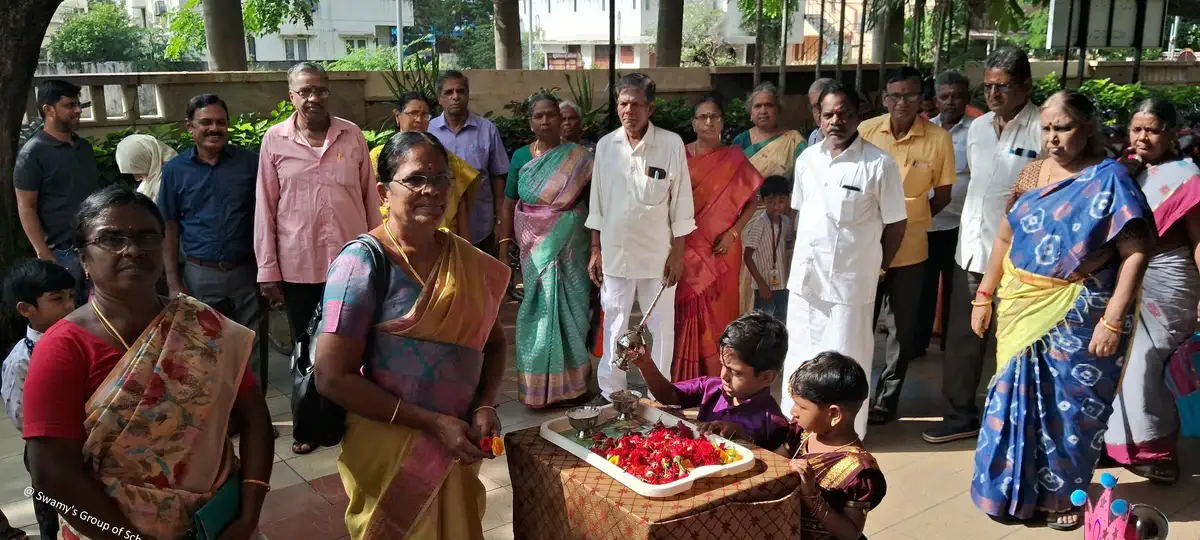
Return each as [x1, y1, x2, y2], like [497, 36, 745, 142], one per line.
[512, 143, 593, 407]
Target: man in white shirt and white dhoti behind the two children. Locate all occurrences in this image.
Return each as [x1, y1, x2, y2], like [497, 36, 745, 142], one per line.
[781, 83, 906, 438]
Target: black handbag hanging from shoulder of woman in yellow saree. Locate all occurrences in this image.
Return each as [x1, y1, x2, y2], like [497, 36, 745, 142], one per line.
[292, 234, 391, 446]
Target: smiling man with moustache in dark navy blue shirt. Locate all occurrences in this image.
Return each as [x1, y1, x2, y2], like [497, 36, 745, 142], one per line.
[158, 94, 262, 340]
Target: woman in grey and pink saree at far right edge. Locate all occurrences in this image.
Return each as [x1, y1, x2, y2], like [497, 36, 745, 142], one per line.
[1104, 97, 1200, 485]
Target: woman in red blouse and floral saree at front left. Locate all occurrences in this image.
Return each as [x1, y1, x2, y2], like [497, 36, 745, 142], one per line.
[24, 186, 274, 539]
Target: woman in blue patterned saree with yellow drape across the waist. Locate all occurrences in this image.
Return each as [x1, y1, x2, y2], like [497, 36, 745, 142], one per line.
[971, 90, 1153, 530]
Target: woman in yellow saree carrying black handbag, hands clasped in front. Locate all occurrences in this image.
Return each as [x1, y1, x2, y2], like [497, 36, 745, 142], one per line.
[314, 132, 509, 540]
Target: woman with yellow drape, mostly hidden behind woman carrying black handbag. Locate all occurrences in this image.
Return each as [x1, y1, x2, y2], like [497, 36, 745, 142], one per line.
[371, 92, 480, 234]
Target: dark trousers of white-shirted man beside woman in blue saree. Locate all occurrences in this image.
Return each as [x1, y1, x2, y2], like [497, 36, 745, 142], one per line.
[942, 268, 996, 427]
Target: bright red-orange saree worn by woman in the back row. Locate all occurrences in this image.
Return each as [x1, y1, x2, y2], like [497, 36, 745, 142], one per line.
[671, 146, 763, 382]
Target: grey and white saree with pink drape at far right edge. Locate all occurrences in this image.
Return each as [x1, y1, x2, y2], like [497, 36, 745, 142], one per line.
[1104, 160, 1200, 464]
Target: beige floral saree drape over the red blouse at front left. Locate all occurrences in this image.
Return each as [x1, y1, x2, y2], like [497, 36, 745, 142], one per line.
[59, 295, 254, 540]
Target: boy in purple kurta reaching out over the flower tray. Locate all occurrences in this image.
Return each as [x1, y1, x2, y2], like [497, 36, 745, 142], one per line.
[634, 311, 788, 450]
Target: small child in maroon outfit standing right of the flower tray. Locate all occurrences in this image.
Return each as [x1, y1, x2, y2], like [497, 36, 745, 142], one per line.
[787, 352, 888, 540]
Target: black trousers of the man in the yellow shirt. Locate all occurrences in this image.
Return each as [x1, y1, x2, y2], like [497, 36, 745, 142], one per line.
[868, 263, 925, 415]
